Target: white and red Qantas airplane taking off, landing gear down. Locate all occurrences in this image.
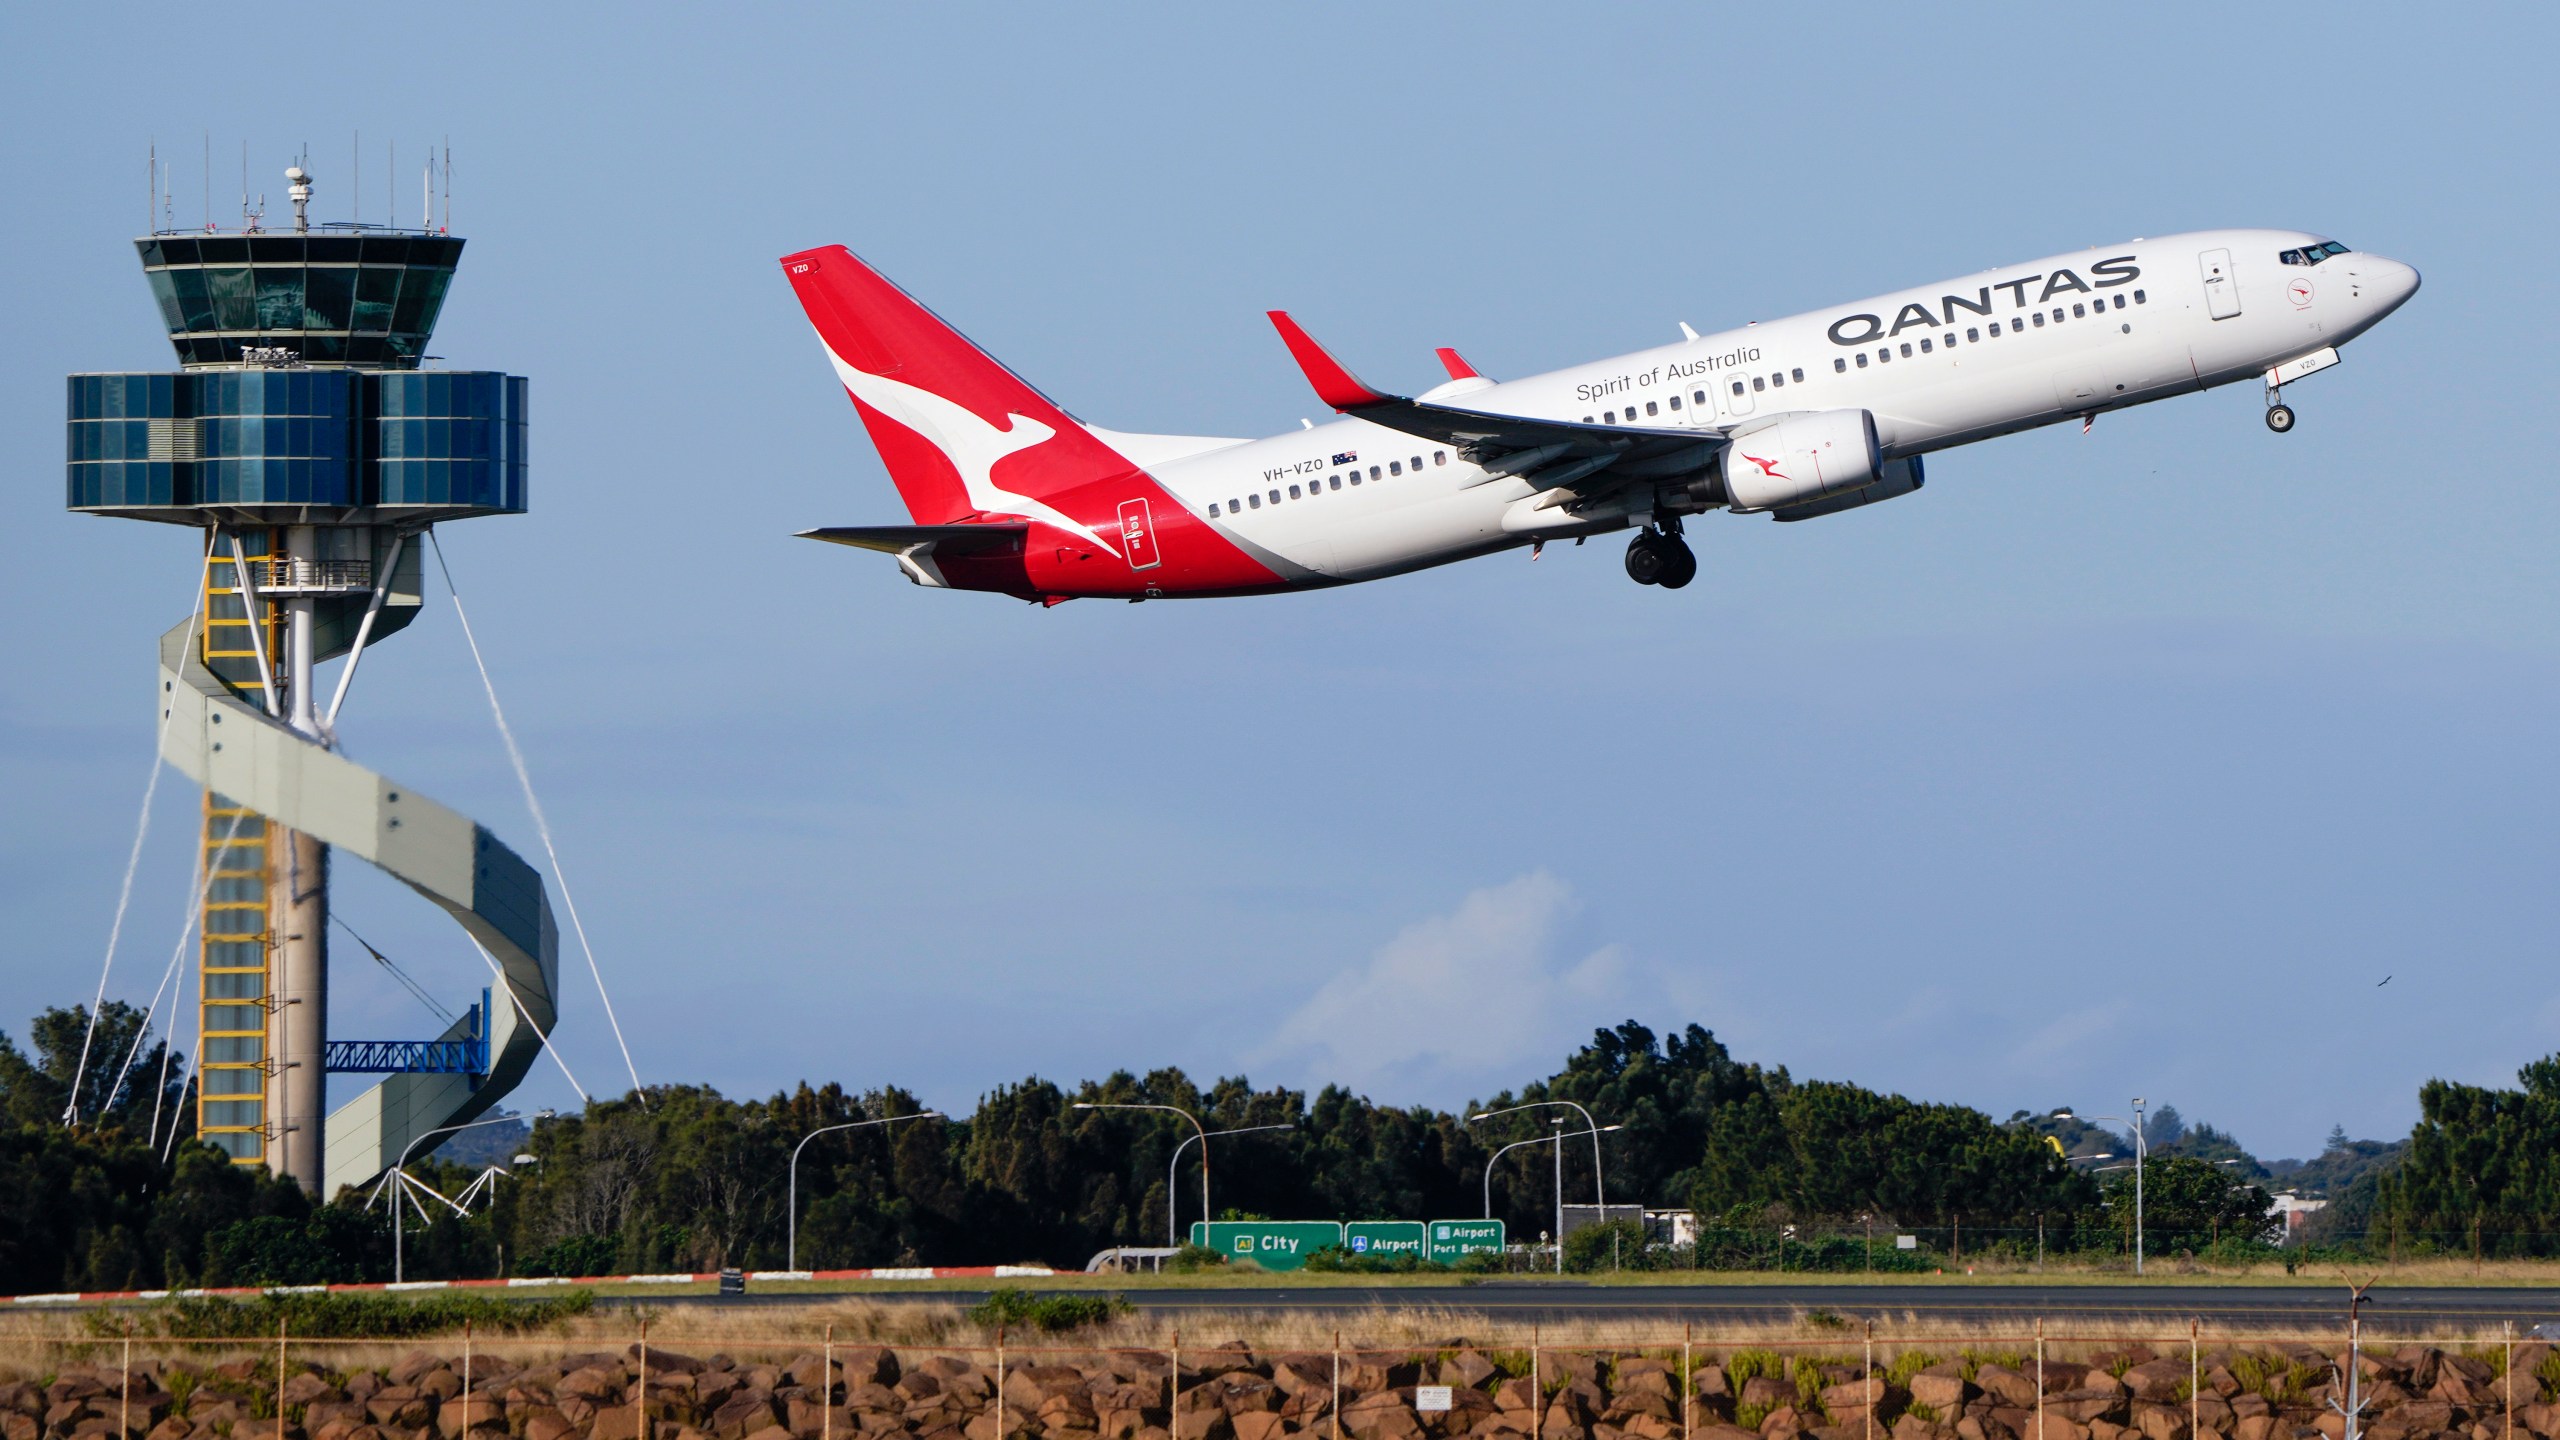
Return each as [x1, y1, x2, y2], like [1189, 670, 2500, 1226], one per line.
[781, 231, 2419, 605]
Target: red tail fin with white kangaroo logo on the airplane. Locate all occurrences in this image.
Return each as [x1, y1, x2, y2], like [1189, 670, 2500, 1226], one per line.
[783, 246, 1137, 527]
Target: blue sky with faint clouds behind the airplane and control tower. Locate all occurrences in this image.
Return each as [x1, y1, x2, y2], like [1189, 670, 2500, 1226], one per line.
[0, 5, 2560, 1156]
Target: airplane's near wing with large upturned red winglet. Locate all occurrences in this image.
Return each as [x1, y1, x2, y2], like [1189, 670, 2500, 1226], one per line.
[1270, 310, 1723, 492]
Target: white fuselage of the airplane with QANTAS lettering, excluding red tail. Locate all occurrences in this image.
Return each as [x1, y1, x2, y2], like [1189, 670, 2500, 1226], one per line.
[1132, 231, 2417, 584]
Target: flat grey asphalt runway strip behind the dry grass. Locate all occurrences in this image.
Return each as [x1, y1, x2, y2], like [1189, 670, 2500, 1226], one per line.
[645, 1281, 2560, 1330]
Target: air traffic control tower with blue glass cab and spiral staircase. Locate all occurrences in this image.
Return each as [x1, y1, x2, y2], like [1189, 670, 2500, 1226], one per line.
[67, 167, 558, 1199]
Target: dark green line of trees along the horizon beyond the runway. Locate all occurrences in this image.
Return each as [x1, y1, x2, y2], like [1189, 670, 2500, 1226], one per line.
[0, 1004, 2560, 1291]
